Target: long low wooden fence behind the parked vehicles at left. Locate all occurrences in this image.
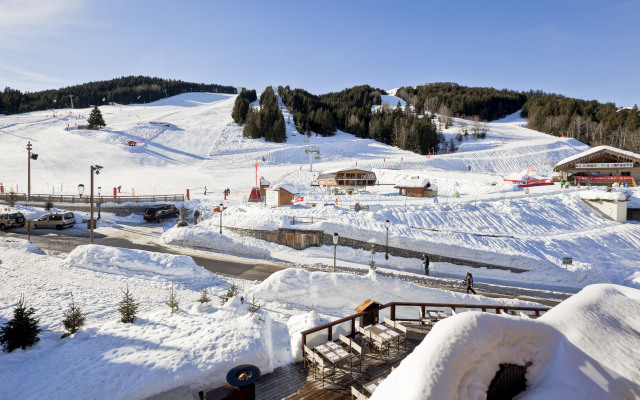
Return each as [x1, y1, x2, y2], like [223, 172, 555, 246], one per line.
[0, 193, 184, 204]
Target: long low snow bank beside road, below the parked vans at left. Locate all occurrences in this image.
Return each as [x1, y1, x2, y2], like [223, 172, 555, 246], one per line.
[65, 244, 211, 278]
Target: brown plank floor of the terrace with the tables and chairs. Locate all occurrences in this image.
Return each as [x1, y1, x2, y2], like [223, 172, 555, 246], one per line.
[256, 325, 429, 400]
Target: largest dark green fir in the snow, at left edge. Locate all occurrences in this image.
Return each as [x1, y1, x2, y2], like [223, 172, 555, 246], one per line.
[0, 295, 41, 353]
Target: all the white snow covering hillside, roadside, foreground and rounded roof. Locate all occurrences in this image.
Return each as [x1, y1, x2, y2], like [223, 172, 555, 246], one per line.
[0, 91, 640, 399]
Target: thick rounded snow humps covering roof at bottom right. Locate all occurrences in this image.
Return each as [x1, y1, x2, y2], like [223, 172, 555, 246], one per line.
[372, 285, 640, 399]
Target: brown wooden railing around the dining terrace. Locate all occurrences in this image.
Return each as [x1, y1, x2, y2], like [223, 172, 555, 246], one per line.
[301, 302, 550, 348]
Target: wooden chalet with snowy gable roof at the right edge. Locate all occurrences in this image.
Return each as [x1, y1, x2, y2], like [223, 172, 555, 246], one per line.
[553, 146, 640, 186]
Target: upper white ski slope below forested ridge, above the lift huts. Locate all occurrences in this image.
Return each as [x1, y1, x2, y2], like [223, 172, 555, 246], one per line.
[0, 93, 587, 193]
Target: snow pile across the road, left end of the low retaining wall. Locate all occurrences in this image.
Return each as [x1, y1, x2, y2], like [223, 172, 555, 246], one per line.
[160, 218, 270, 258]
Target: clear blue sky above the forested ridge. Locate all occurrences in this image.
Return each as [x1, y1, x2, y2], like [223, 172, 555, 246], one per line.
[0, 0, 640, 106]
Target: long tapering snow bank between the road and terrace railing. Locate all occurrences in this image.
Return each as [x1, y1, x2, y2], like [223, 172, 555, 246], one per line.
[252, 268, 539, 312]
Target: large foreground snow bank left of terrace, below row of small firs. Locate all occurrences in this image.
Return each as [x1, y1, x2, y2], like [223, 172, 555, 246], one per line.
[0, 294, 273, 399]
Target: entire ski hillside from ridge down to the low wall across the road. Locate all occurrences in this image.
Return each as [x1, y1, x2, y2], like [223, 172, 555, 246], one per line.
[5, 93, 640, 287]
